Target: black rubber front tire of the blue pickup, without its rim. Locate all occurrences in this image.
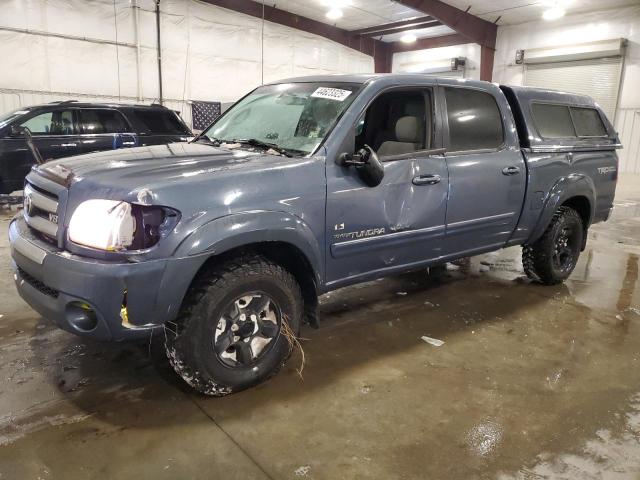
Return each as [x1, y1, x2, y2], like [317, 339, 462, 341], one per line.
[165, 254, 304, 396]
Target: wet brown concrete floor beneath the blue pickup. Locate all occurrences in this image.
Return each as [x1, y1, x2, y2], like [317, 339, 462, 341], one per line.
[0, 177, 640, 480]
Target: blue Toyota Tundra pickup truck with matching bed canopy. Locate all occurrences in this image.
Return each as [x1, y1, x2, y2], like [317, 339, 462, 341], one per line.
[9, 74, 620, 395]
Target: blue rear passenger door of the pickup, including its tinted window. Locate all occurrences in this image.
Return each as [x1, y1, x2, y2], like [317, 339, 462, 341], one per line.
[439, 82, 527, 255]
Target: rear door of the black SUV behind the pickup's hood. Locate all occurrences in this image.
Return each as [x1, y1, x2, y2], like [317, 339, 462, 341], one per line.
[78, 108, 137, 153]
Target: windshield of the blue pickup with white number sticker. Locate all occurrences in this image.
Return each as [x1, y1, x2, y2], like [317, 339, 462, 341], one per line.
[203, 83, 360, 156]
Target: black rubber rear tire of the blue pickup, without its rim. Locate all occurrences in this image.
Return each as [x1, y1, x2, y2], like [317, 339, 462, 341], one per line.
[522, 207, 586, 285]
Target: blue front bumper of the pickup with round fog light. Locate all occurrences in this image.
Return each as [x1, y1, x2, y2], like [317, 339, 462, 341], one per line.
[9, 215, 201, 340]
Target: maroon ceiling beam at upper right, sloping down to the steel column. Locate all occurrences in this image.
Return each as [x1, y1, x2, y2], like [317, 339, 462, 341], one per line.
[396, 0, 498, 49]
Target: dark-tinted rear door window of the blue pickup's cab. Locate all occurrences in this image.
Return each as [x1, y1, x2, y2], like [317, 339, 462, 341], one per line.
[444, 87, 504, 152]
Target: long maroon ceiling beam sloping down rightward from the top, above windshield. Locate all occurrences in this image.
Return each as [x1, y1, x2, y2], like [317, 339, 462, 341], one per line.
[202, 0, 382, 56]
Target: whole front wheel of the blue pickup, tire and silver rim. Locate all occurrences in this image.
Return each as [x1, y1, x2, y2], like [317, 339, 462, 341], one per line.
[165, 255, 303, 396]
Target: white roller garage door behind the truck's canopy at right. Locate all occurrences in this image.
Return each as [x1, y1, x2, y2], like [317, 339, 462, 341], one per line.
[524, 57, 622, 122]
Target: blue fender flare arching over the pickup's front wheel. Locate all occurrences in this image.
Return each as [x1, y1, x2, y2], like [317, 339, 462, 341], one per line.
[174, 210, 324, 285]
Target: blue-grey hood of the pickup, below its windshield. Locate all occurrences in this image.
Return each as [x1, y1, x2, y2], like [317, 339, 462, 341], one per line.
[38, 143, 299, 191]
